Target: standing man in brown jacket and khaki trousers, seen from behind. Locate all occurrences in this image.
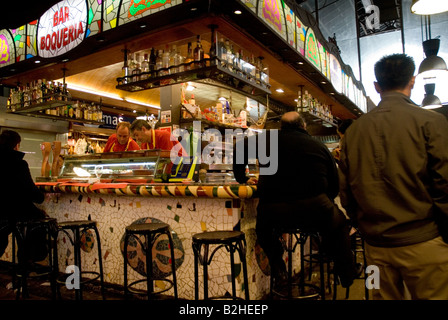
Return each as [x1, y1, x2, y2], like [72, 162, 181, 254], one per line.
[340, 54, 448, 300]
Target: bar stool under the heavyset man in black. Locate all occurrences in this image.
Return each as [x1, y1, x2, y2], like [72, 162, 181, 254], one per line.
[270, 228, 325, 300]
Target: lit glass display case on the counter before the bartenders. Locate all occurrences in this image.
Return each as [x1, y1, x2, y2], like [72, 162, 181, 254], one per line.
[58, 151, 173, 182]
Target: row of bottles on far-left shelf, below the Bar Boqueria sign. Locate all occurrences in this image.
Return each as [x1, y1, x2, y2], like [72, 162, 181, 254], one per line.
[8, 79, 71, 112]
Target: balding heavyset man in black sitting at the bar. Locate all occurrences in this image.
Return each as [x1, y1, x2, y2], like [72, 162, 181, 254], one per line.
[233, 112, 356, 287]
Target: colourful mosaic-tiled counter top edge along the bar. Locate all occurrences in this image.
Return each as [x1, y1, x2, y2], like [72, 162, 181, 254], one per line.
[36, 182, 257, 199]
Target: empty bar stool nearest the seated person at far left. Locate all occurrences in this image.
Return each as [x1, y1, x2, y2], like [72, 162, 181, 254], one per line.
[58, 220, 104, 300]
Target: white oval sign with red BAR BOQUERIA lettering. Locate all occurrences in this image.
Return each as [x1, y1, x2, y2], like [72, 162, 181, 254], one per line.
[37, 0, 87, 58]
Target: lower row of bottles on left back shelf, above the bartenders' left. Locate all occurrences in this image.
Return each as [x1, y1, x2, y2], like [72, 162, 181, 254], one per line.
[42, 101, 103, 122]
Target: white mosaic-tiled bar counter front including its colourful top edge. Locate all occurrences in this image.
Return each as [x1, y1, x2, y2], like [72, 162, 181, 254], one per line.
[33, 183, 269, 299]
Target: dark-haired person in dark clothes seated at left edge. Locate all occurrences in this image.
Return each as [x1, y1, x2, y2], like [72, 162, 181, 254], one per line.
[0, 130, 45, 260]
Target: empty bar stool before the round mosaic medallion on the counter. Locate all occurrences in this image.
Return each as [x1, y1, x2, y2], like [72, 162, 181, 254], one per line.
[123, 223, 177, 300]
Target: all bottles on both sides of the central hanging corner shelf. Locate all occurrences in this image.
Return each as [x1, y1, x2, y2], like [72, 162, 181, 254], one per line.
[118, 33, 269, 85]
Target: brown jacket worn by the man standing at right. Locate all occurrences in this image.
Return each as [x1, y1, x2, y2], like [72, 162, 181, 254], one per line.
[345, 93, 447, 246]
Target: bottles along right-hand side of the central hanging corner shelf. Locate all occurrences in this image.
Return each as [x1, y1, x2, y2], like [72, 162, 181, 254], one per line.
[217, 38, 269, 84]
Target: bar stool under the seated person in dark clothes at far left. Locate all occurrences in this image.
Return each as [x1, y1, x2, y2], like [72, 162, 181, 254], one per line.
[12, 218, 58, 299]
